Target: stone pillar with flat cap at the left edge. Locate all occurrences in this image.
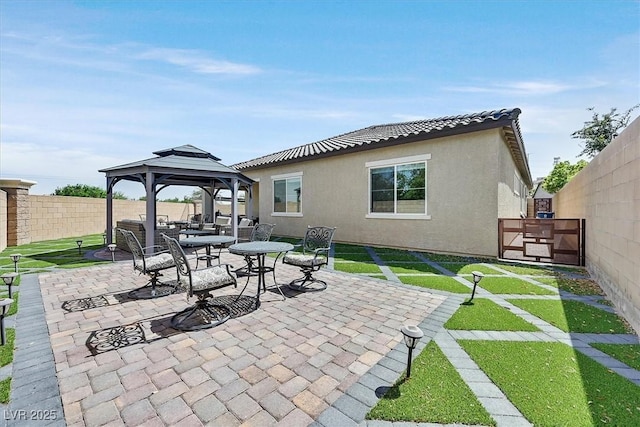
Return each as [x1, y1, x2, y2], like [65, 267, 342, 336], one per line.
[0, 179, 36, 246]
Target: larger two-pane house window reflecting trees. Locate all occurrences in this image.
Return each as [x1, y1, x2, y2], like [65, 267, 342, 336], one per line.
[366, 154, 431, 219]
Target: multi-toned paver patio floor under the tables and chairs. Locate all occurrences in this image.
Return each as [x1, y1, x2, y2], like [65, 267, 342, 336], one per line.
[30, 253, 446, 426]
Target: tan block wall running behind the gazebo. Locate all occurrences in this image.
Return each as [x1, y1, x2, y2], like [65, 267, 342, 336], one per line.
[29, 195, 194, 242]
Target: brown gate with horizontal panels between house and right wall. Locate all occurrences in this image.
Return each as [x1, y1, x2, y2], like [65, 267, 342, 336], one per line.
[498, 218, 585, 265]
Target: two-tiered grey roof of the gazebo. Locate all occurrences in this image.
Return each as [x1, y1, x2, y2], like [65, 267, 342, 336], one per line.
[99, 144, 253, 187]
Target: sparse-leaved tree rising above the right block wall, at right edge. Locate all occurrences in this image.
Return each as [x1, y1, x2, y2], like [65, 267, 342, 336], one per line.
[571, 104, 640, 157]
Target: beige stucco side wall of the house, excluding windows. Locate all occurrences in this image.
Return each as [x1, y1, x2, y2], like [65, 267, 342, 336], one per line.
[244, 129, 522, 256]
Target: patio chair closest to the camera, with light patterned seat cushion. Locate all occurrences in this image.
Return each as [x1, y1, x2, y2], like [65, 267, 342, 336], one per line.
[163, 235, 237, 331]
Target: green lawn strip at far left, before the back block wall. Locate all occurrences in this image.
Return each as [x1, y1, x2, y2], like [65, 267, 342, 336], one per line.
[0, 234, 110, 274]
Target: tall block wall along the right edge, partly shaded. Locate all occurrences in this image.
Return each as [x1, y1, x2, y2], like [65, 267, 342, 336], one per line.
[553, 118, 640, 334]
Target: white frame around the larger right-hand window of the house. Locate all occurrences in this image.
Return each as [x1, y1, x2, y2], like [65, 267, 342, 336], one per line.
[365, 153, 431, 220]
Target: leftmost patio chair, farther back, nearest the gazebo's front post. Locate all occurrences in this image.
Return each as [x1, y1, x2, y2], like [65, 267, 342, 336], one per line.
[117, 228, 175, 299]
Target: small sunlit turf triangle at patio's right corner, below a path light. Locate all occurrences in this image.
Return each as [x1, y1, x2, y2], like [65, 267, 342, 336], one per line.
[444, 298, 540, 332]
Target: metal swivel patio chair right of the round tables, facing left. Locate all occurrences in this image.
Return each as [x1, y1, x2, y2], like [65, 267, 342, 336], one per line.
[282, 226, 336, 292]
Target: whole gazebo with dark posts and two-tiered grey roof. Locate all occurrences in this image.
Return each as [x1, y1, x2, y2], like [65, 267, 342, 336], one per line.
[99, 145, 253, 246]
